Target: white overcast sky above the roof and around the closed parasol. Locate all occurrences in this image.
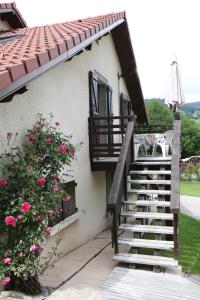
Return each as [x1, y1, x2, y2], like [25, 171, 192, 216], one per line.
[5, 0, 200, 102]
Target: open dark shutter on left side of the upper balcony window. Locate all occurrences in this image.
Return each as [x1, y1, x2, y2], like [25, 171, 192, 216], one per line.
[89, 71, 98, 115]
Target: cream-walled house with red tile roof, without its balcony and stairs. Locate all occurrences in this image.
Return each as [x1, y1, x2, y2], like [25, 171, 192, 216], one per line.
[0, 3, 147, 253]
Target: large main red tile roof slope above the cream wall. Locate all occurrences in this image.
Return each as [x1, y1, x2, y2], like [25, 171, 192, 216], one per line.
[0, 13, 125, 91]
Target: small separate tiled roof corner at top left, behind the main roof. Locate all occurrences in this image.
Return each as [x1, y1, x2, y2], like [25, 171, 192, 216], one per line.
[0, 2, 27, 28]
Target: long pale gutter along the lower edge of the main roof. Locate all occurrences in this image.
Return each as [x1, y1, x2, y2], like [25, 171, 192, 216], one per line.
[0, 18, 125, 101]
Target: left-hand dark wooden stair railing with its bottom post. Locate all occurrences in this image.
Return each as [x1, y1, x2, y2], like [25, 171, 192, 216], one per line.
[108, 121, 134, 254]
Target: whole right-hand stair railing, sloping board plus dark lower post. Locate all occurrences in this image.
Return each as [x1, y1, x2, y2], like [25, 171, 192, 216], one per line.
[170, 113, 181, 258]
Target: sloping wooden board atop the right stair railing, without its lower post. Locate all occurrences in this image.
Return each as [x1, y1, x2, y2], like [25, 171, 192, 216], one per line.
[170, 119, 181, 213]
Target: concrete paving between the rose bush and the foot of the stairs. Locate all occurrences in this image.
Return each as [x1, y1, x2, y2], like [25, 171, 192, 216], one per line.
[41, 231, 116, 300]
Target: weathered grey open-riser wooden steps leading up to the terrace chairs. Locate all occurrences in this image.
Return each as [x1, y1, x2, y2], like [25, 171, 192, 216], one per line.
[113, 158, 178, 268]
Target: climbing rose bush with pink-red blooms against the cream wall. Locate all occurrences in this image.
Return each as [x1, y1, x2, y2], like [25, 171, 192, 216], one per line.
[0, 114, 80, 294]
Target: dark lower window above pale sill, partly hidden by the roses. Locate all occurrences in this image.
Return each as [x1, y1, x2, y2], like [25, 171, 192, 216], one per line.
[49, 180, 77, 226]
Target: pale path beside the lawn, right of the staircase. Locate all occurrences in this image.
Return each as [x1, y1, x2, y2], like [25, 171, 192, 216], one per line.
[181, 195, 200, 220]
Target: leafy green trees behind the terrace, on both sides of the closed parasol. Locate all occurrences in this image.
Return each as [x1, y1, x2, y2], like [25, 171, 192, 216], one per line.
[146, 99, 200, 158]
